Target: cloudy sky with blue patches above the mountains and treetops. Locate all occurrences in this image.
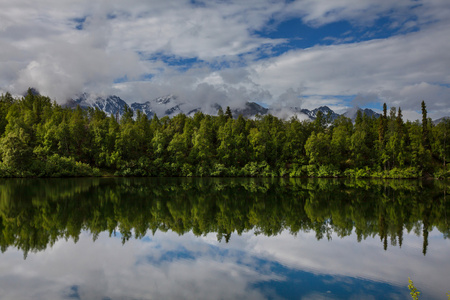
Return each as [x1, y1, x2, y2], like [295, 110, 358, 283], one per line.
[0, 0, 450, 120]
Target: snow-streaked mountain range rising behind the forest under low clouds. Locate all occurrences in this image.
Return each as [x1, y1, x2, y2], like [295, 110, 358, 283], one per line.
[66, 93, 380, 121]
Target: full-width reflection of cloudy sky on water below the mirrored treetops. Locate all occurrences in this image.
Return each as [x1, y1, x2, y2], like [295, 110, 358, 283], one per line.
[0, 232, 450, 299]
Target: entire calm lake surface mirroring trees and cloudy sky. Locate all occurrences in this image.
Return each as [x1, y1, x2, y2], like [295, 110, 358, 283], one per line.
[0, 178, 450, 300]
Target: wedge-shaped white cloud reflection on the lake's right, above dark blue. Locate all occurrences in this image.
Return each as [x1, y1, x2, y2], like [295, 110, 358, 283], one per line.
[229, 232, 450, 298]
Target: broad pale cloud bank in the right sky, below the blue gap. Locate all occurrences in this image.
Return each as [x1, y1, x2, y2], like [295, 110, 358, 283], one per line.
[252, 19, 450, 117]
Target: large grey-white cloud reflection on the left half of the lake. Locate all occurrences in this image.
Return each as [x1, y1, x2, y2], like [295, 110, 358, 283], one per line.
[0, 233, 280, 299]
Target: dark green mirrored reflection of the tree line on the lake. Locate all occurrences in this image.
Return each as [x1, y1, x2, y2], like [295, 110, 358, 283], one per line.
[0, 178, 450, 256]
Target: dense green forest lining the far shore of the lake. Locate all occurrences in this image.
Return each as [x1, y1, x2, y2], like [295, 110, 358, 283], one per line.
[0, 89, 450, 178]
